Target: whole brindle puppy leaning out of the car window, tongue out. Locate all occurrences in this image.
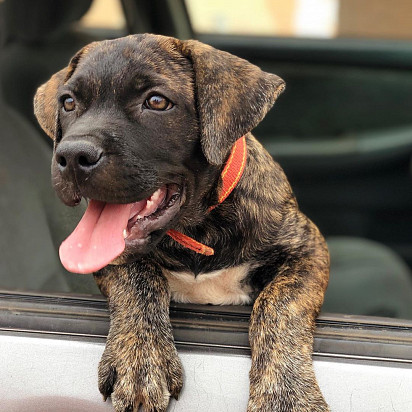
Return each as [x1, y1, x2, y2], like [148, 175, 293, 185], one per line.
[35, 35, 329, 412]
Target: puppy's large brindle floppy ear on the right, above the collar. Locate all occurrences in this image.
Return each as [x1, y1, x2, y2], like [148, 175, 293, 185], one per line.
[181, 40, 285, 165]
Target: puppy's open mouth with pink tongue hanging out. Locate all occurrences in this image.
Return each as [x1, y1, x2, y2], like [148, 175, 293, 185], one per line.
[59, 184, 182, 273]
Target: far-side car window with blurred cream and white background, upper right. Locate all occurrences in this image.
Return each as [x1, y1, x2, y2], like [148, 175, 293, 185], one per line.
[186, 0, 412, 39]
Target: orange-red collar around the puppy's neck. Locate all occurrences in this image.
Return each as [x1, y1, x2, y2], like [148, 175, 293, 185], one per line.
[166, 136, 247, 256]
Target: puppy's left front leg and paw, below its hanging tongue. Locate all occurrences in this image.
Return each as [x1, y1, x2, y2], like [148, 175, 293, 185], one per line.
[95, 260, 183, 412]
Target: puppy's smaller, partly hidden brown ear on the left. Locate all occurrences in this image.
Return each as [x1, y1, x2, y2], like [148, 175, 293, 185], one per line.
[34, 43, 95, 139]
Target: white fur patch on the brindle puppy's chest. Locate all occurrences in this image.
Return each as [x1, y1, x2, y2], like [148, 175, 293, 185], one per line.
[164, 264, 252, 305]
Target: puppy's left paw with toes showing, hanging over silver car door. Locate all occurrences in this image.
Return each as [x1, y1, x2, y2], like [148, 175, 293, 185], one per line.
[99, 336, 183, 412]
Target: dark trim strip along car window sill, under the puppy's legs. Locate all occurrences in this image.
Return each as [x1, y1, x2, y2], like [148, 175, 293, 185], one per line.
[0, 291, 412, 365]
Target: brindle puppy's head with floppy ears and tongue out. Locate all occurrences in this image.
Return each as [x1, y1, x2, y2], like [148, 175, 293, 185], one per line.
[34, 35, 284, 273]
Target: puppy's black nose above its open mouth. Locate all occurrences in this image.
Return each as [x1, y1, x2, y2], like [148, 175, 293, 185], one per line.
[55, 140, 103, 173]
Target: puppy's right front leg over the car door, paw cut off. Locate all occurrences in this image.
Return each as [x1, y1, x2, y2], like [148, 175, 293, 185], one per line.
[247, 249, 329, 412]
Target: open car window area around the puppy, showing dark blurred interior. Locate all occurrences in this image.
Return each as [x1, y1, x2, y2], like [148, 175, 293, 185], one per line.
[0, 0, 412, 319]
